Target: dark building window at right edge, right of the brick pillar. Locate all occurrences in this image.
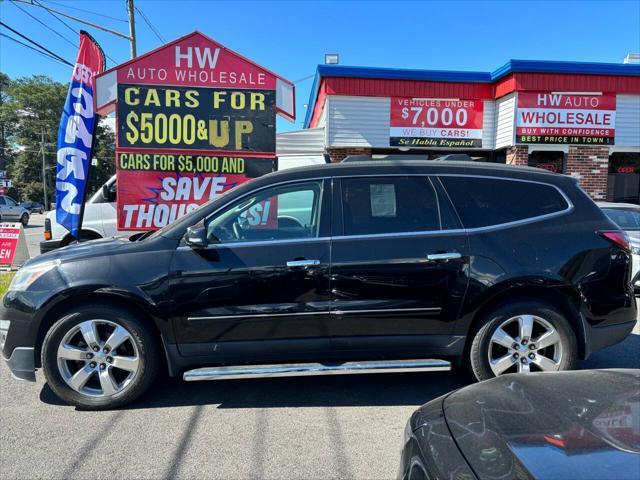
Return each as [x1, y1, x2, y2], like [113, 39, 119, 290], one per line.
[607, 152, 640, 203]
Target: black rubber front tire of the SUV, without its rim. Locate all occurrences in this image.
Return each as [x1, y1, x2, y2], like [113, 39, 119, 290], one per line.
[42, 305, 160, 410]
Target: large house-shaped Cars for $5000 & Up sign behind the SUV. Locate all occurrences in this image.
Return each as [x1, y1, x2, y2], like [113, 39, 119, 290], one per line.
[97, 32, 295, 230]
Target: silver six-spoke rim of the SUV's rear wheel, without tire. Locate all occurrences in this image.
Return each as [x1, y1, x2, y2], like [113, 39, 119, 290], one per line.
[489, 315, 563, 377]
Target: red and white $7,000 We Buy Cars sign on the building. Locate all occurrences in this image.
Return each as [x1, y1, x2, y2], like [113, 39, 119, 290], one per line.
[389, 97, 484, 148]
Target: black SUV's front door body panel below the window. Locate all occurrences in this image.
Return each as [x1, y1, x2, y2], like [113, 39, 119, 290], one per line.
[172, 240, 330, 354]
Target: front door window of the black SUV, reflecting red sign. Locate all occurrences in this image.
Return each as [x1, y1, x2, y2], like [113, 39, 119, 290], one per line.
[206, 181, 322, 242]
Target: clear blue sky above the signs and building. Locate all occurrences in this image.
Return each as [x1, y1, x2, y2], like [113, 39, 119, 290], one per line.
[0, 0, 640, 131]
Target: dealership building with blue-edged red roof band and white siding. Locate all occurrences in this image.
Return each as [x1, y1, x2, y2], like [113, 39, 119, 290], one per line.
[277, 60, 640, 203]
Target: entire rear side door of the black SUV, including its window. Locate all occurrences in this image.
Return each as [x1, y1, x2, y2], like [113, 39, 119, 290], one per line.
[331, 176, 469, 349]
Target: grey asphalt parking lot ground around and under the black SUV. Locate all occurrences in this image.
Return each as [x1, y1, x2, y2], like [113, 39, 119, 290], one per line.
[0, 215, 640, 480]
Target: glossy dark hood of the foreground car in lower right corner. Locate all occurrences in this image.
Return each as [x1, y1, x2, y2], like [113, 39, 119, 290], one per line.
[444, 370, 640, 480]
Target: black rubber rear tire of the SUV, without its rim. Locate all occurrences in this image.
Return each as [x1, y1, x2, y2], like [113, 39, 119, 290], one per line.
[468, 301, 578, 381]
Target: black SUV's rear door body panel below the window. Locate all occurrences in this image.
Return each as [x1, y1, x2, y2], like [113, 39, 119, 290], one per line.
[331, 233, 468, 336]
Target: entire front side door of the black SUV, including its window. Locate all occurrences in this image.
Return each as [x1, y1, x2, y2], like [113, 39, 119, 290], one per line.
[171, 181, 331, 361]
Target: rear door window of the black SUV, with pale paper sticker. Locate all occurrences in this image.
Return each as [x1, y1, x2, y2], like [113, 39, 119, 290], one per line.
[342, 176, 440, 235]
